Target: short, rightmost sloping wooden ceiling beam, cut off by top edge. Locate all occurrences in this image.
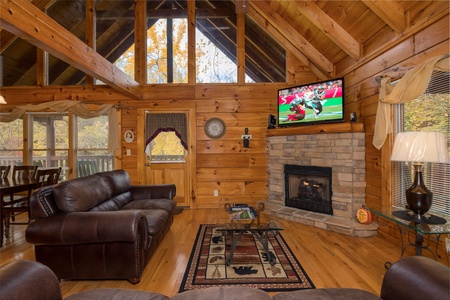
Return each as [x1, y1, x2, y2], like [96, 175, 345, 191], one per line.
[362, 0, 406, 33]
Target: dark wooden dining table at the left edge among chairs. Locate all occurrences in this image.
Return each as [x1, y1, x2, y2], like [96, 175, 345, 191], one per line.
[0, 178, 36, 247]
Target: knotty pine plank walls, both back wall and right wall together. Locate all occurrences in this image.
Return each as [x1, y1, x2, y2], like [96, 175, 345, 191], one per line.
[2, 15, 450, 219]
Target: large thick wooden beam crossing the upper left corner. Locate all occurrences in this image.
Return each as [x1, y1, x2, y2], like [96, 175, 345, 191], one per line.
[0, 0, 143, 99]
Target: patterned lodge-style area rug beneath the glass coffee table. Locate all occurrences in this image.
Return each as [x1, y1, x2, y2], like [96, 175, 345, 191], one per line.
[179, 224, 315, 292]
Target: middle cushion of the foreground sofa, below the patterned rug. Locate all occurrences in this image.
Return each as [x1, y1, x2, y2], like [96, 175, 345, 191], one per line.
[170, 287, 272, 300]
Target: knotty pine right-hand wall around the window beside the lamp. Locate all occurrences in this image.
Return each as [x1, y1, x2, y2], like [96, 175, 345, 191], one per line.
[345, 15, 450, 248]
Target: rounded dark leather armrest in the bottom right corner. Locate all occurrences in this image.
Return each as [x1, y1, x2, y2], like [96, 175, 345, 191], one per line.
[380, 256, 450, 300]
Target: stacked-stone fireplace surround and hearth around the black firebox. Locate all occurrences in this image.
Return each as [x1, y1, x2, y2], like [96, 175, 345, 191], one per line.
[267, 132, 377, 237]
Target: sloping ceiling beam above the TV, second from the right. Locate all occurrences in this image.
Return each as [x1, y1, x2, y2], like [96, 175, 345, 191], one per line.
[295, 1, 361, 60]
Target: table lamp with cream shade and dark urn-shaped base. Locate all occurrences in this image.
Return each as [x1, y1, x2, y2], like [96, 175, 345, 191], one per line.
[391, 132, 449, 219]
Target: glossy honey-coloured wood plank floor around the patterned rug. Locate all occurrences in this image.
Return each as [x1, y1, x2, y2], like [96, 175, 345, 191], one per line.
[0, 209, 414, 297]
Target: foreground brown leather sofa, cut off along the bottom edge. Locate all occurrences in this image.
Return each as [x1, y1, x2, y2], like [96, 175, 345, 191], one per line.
[0, 256, 450, 300]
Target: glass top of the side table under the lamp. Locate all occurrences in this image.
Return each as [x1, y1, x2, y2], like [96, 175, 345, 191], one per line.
[364, 206, 450, 234]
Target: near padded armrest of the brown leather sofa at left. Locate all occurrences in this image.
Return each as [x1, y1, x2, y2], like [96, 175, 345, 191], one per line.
[25, 210, 148, 245]
